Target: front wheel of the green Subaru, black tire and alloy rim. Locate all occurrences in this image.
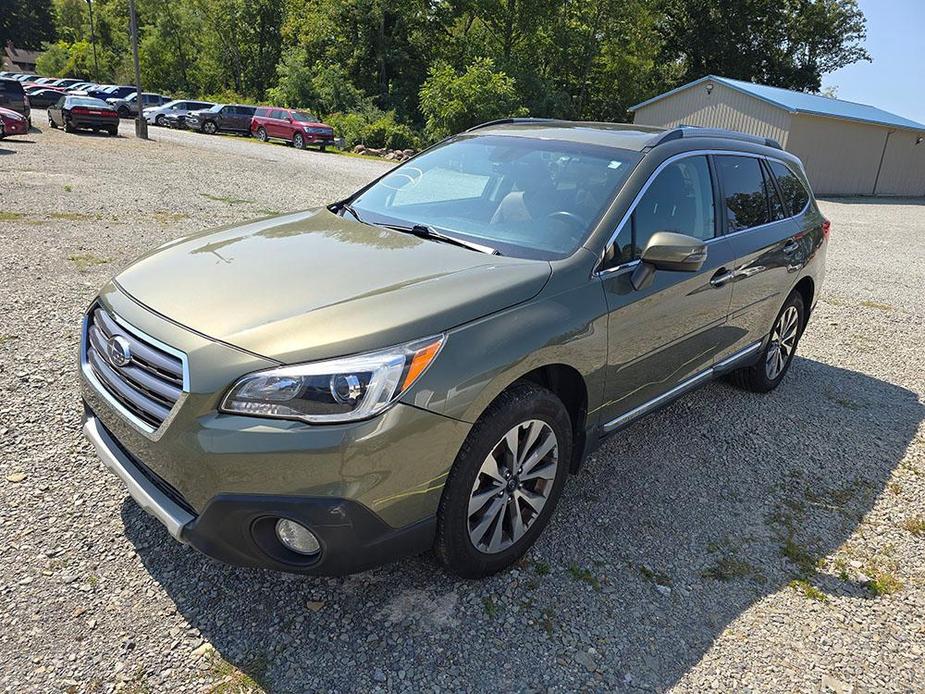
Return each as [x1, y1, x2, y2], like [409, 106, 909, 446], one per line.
[434, 383, 572, 578]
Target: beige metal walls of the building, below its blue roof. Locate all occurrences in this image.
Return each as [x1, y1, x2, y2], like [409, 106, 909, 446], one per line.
[634, 83, 925, 196]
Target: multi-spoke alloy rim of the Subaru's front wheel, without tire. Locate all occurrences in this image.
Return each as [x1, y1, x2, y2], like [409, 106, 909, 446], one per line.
[468, 419, 559, 554]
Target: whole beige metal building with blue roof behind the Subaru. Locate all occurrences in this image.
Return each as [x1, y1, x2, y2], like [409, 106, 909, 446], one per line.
[630, 75, 925, 196]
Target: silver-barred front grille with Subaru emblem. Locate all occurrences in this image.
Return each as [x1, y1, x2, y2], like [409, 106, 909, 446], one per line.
[84, 305, 183, 430]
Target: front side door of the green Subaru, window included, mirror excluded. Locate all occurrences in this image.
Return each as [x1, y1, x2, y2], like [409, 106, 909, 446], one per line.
[600, 153, 737, 431]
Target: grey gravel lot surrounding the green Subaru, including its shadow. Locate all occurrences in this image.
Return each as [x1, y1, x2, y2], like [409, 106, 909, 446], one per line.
[0, 118, 925, 692]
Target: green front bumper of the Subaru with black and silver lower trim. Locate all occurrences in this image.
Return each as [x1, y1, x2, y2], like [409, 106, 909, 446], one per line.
[81, 285, 470, 574]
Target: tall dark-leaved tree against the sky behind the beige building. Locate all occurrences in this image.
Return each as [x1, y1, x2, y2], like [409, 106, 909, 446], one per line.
[661, 0, 870, 91]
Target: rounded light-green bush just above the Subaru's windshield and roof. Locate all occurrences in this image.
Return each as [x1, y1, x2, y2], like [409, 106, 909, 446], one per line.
[421, 58, 527, 140]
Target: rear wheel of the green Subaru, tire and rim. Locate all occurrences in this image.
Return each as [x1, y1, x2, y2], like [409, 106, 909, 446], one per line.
[730, 292, 806, 393]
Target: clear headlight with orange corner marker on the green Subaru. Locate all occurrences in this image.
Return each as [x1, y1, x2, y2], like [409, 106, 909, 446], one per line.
[221, 335, 444, 423]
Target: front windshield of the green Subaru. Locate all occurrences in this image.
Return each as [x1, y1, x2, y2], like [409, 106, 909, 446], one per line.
[351, 135, 640, 260]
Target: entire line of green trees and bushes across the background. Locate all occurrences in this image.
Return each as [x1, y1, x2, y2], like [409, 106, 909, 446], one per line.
[7, 0, 870, 146]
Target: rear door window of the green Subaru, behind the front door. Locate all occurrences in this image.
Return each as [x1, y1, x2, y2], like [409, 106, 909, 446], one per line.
[714, 156, 775, 231]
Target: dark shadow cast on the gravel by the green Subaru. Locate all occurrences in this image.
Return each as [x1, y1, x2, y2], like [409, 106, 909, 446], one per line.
[122, 358, 925, 691]
